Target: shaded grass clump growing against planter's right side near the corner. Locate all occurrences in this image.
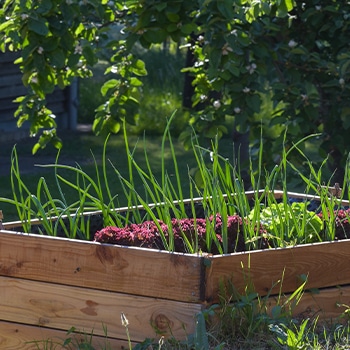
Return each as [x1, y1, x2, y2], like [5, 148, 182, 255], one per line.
[209, 273, 307, 349]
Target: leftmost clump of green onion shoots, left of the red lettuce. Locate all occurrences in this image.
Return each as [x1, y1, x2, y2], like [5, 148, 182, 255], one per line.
[1, 141, 124, 239]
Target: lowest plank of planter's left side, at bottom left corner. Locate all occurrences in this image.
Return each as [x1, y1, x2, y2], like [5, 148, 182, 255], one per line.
[0, 321, 128, 350]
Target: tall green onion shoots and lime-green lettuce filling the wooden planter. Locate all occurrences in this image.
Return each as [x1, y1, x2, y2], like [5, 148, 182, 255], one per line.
[0, 115, 349, 254]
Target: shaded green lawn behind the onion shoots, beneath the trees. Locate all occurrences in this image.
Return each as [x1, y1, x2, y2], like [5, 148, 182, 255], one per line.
[0, 132, 232, 221]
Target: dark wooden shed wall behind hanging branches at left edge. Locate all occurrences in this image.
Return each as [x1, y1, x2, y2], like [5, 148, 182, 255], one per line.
[0, 52, 78, 141]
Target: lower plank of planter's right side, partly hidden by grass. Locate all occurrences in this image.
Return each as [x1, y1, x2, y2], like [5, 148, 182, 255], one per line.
[266, 286, 350, 321]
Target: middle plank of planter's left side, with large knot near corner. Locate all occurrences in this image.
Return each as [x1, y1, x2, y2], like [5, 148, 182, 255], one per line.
[0, 277, 201, 342]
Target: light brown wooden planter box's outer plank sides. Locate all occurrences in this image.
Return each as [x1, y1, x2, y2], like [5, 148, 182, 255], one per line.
[0, 191, 350, 350]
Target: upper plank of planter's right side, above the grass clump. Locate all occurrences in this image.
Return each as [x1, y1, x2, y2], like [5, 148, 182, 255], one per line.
[206, 240, 350, 301]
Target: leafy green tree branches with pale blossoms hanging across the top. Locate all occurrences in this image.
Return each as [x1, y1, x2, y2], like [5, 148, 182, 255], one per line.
[0, 0, 350, 179]
